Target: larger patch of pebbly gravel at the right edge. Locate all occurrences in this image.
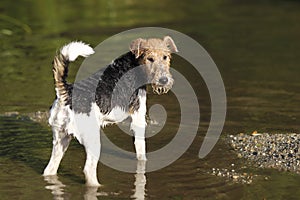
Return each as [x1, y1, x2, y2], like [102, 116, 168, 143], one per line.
[229, 132, 300, 174]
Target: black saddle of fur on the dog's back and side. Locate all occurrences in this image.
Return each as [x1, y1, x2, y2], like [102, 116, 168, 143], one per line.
[66, 52, 147, 114]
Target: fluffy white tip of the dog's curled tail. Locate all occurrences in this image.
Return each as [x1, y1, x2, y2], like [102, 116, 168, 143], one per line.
[60, 41, 95, 61]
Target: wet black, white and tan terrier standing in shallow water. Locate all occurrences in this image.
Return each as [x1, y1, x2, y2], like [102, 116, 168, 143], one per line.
[43, 36, 178, 186]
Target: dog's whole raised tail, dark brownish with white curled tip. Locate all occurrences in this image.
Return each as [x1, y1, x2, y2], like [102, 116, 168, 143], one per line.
[53, 42, 94, 102]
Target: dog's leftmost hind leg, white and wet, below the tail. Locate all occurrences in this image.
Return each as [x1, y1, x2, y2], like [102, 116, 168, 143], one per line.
[43, 127, 72, 176]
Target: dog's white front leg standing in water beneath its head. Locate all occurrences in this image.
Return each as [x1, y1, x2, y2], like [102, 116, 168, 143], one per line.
[130, 90, 147, 160]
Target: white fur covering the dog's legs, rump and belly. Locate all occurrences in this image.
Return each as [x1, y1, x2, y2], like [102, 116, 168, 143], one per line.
[44, 90, 147, 186]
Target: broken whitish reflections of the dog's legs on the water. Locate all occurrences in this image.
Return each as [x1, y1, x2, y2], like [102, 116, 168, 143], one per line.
[44, 160, 146, 200]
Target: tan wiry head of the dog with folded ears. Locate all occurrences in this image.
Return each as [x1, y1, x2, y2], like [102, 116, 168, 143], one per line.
[130, 36, 178, 94]
